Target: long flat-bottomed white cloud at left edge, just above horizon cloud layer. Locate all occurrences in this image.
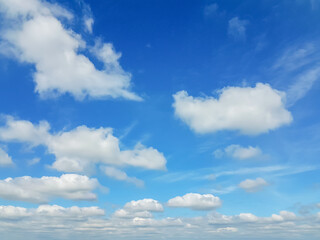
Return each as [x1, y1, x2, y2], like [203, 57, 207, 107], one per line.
[0, 174, 99, 203]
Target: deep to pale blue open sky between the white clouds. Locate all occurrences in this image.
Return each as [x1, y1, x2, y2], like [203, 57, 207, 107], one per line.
[0, 0, 320, 216]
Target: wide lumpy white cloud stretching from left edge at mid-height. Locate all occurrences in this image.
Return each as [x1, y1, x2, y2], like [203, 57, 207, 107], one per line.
[0, 116, 166, 172]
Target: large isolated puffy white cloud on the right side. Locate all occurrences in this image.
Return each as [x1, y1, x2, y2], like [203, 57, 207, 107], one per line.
[173, 83, 292, 135]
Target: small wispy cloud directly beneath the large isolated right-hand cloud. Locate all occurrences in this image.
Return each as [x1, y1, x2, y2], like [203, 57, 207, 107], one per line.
[214, 144, 262, 160]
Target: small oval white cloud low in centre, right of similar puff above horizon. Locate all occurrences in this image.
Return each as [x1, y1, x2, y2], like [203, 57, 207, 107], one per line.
[168, 193, 222, 210]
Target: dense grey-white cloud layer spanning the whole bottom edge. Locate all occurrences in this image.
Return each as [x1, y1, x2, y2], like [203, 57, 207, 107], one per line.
[0, 202, 319, 240]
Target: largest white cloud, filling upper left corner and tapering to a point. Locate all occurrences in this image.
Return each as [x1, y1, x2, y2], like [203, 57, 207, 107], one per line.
[0, 0, 142, 101]
